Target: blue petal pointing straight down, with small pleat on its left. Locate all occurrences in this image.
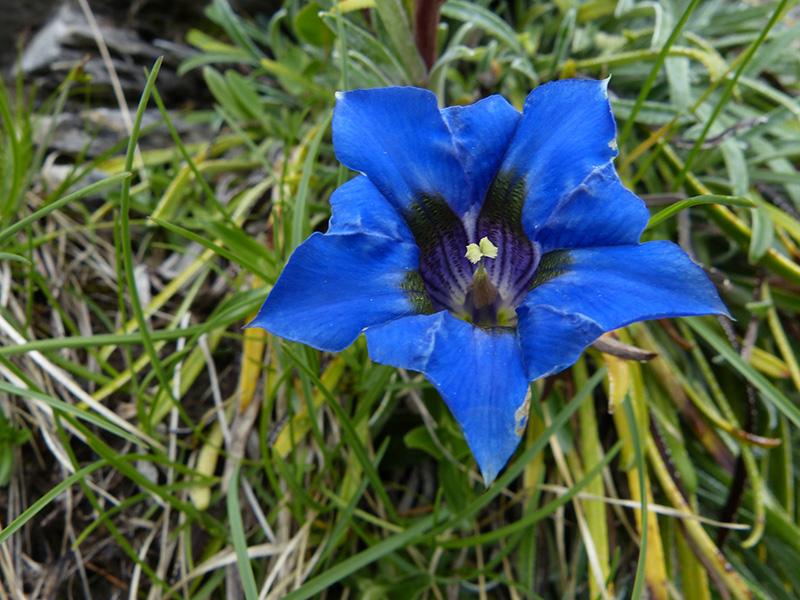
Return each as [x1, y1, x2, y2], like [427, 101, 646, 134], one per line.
[366, 312, 528, 485]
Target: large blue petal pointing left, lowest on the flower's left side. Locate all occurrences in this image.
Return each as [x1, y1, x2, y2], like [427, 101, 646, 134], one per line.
[248, 233, 419, 352]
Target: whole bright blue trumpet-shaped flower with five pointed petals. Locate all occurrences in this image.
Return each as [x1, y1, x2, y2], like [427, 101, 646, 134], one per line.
[250, 80, 726, 484]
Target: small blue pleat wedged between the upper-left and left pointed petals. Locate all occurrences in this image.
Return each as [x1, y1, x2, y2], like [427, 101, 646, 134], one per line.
[328, 177, 414, 243]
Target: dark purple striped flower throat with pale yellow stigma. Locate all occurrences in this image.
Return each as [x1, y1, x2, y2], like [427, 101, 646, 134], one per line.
[405, 174, 540, 327]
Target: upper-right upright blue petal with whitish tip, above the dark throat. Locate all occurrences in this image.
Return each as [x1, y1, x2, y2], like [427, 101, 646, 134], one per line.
[500, 79, 617, 239]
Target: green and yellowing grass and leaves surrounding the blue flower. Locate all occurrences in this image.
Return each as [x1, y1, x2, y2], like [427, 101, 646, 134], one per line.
[0, 0, 800, 599]
